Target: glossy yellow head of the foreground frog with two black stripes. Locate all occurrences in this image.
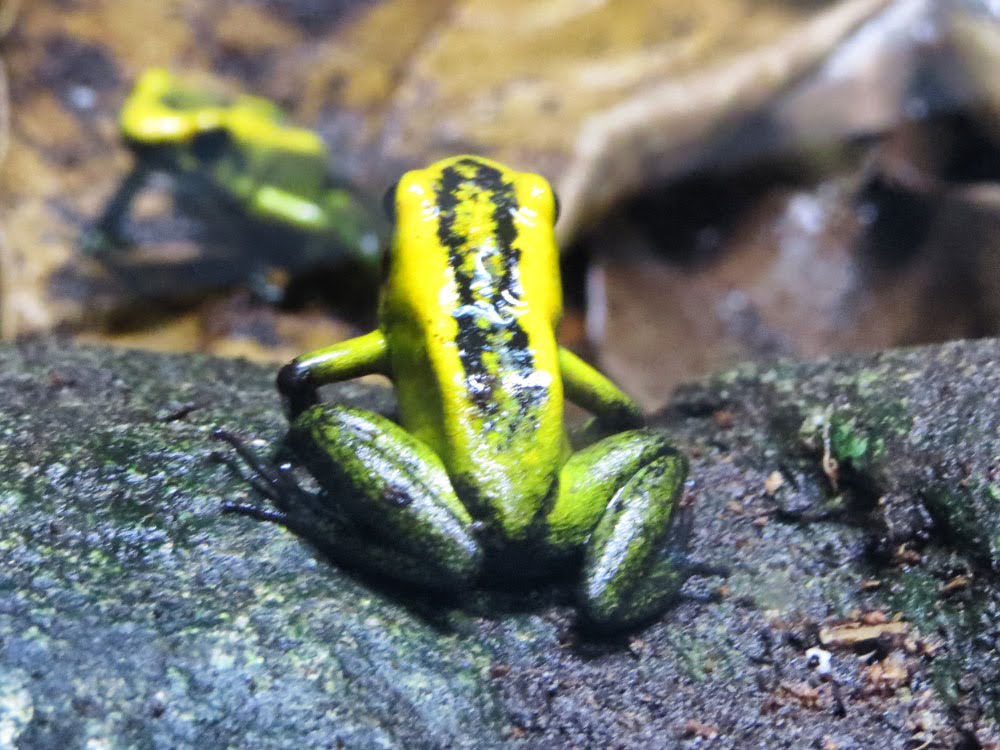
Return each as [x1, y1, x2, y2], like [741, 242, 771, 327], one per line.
[385, 155, 562, 322]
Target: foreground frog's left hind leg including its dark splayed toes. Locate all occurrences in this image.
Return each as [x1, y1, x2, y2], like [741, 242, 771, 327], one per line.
[214, 418, 481, 590]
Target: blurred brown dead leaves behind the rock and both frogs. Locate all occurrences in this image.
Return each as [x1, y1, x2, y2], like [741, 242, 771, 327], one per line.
[0, 0, 1000, 408]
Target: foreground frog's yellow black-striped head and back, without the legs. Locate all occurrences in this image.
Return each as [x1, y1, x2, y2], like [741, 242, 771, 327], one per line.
[382, 157, 565, 538]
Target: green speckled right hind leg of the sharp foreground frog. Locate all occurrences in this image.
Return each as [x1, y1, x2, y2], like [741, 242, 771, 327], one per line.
[548, 430, 690, 629]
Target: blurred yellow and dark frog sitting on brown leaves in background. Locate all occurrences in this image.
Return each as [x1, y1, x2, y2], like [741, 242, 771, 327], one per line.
[82, 68, 381, 296]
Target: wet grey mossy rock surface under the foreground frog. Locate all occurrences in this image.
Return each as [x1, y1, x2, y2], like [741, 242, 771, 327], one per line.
[0, 340, 1000, 750]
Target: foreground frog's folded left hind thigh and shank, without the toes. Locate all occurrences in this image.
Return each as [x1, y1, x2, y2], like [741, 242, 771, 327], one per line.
[288, 404, 482, 590]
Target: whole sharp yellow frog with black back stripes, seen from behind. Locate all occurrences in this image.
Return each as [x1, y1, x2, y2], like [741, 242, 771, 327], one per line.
[254, 156, 690, 629]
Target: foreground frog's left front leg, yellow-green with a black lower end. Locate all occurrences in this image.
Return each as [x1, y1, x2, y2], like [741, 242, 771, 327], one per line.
[278, 329, 389, 419]
